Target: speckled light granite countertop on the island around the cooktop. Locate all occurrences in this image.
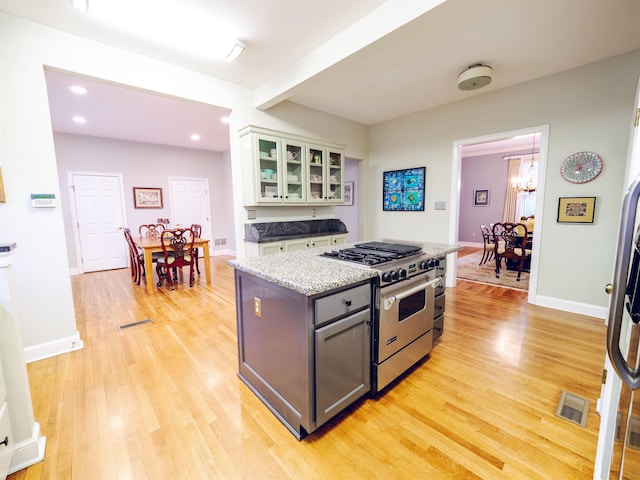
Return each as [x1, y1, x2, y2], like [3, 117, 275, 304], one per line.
[229, 242, 463, 297]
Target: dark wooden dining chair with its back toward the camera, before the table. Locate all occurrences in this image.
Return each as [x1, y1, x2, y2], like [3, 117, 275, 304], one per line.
[156, 228, 195, 290]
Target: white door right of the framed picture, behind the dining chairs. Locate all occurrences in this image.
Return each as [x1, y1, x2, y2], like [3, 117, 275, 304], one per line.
[169, 177, 213, 250]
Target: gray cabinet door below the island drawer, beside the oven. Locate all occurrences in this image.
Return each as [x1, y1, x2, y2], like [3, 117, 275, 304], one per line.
[315, 309, 371, 427]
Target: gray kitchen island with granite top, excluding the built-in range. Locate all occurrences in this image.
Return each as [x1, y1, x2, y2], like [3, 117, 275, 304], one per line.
[229, 240, 460, 439]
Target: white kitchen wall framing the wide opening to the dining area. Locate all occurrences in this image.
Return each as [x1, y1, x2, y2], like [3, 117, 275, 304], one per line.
[0, 13, 368, 353]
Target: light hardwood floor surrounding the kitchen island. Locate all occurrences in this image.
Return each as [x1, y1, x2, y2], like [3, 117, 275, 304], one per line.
[9, 253, 605, 480]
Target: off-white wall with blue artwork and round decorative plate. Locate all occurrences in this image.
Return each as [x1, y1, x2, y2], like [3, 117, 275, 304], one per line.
[369, 50, 640, 314]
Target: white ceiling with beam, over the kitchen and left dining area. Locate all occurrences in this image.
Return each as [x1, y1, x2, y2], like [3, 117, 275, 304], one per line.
[0, 0, 640, 151]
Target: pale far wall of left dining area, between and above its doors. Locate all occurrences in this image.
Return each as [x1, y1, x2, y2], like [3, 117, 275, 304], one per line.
[54, 133, 235, 269]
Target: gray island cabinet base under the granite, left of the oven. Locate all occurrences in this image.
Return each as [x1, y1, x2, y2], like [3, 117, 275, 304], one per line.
[235, 269, 372, 438]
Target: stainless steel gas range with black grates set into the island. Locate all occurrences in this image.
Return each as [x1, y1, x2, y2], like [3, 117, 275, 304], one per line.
[323, 242, 446, 393]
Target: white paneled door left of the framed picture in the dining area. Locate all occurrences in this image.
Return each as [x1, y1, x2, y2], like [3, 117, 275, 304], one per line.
[71, 174, 127, 272]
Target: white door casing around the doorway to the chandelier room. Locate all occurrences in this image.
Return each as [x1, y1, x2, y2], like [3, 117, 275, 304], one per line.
[448, 125, 549, 304]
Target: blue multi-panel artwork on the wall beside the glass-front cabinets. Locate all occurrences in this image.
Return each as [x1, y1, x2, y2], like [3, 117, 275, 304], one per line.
[382, 167, 427, 212]
